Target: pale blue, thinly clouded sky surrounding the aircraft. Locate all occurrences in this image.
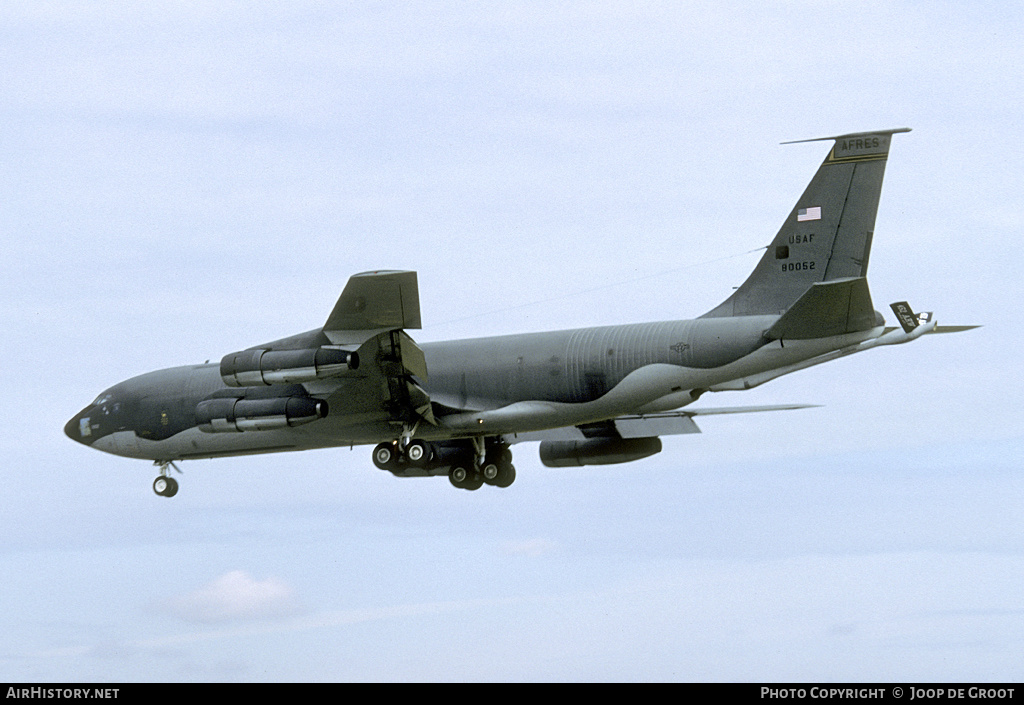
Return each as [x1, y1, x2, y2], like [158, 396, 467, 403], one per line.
[0, 0, 1024, 681]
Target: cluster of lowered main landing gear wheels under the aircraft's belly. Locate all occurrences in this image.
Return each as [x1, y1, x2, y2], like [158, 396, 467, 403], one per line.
[373, 438, 515, 490]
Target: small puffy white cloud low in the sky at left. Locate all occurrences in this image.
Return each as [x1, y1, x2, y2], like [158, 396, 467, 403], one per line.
[169, 571, 298, 624]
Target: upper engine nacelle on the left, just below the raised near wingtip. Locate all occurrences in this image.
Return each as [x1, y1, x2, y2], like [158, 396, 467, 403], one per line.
[220, 346, 359, 386]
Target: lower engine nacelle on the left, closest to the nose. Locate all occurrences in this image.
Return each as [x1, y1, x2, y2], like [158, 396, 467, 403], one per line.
[196, 397, 328, 433]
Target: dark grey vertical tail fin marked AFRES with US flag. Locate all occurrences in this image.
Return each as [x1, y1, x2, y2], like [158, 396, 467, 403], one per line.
[701, 127, 910, 318]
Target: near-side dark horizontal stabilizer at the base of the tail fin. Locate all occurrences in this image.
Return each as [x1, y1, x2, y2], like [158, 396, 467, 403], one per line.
[768, 277, 876, 340]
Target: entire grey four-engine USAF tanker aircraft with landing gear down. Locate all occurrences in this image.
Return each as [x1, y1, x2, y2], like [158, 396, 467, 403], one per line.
[65, 128, 971, 497]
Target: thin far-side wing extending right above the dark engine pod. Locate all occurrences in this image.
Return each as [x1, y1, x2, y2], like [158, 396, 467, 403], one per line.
[504, 404, 818, 444]
